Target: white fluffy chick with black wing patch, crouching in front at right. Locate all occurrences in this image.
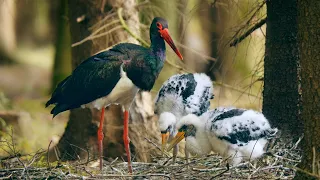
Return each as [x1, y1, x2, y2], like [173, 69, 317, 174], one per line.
[168, 107, 278, 166]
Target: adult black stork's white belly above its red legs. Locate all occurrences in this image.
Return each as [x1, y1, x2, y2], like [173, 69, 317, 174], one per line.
[85, 66, 139, 110]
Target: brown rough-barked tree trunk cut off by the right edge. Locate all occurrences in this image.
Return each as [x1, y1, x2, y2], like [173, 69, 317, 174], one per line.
[295, 0, 320, 179]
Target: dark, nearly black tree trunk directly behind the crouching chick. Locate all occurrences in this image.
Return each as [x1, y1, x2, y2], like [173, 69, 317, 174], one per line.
[263, 0, 302, 137]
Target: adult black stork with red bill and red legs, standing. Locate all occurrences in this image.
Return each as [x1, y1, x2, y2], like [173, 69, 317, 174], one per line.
[46, 17, 183, 173]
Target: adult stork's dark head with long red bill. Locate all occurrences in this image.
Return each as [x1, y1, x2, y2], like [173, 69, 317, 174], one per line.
[150, 17, 183, 60]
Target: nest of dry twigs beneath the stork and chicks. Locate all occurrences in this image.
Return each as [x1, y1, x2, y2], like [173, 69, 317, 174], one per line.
[0, 138, 301, 179]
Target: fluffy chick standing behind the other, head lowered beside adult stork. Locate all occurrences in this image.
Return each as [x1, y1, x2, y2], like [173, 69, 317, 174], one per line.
[155, 73, 213, 163]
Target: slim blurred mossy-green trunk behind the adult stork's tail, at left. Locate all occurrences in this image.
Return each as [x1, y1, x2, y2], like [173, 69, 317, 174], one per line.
[51, 0, 71, 92]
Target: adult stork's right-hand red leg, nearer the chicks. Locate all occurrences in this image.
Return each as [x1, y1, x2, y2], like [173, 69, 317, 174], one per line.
[123, 110, 132, 173]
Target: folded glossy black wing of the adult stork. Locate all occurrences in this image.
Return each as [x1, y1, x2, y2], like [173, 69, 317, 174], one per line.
[46, 43, 145, 116]
